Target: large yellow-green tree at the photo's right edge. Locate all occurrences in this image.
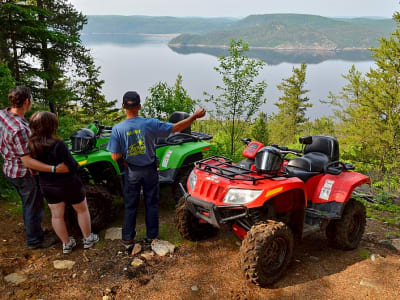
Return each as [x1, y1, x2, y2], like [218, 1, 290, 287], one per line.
[331, 13, 400, 178]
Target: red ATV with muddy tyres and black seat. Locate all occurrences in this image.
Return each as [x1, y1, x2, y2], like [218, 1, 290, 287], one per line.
[175, 136, 370, 286]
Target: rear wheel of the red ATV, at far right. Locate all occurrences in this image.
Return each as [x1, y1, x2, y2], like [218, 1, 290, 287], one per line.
[326, 199, 367, 250]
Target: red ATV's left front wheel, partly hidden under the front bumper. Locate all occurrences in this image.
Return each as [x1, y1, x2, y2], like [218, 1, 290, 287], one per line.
[175, 198, 218, 241]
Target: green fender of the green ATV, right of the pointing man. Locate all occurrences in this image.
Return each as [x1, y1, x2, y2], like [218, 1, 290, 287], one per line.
[156, 141, 211, 183]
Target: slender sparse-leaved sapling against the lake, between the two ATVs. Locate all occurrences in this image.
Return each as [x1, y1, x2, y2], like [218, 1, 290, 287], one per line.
[205, 40, 267, 156]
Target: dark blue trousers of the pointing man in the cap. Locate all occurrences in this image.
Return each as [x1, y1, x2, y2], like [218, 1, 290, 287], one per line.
[122, 164, 160, 241]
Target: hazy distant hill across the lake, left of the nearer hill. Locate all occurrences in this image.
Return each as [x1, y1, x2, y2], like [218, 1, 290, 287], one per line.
[82, 15, 238, 35]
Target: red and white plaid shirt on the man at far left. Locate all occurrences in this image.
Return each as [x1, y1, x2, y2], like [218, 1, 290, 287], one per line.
[0, 108, 30, 178]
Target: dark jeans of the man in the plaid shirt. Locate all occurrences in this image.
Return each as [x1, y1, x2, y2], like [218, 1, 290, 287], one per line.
[7, 175, 44, 246]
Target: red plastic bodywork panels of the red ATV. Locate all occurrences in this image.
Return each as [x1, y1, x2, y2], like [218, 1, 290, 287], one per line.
[187, 157, 370, 239]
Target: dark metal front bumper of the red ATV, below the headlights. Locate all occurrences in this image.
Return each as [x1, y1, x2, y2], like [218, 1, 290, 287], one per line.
[186, 195, 248, 228]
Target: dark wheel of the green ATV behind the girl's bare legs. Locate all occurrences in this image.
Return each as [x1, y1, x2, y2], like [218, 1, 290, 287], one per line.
[65, 184, 114, 234]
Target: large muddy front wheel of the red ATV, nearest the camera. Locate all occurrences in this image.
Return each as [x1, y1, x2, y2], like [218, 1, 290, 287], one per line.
[239, 220, 293, 286]
